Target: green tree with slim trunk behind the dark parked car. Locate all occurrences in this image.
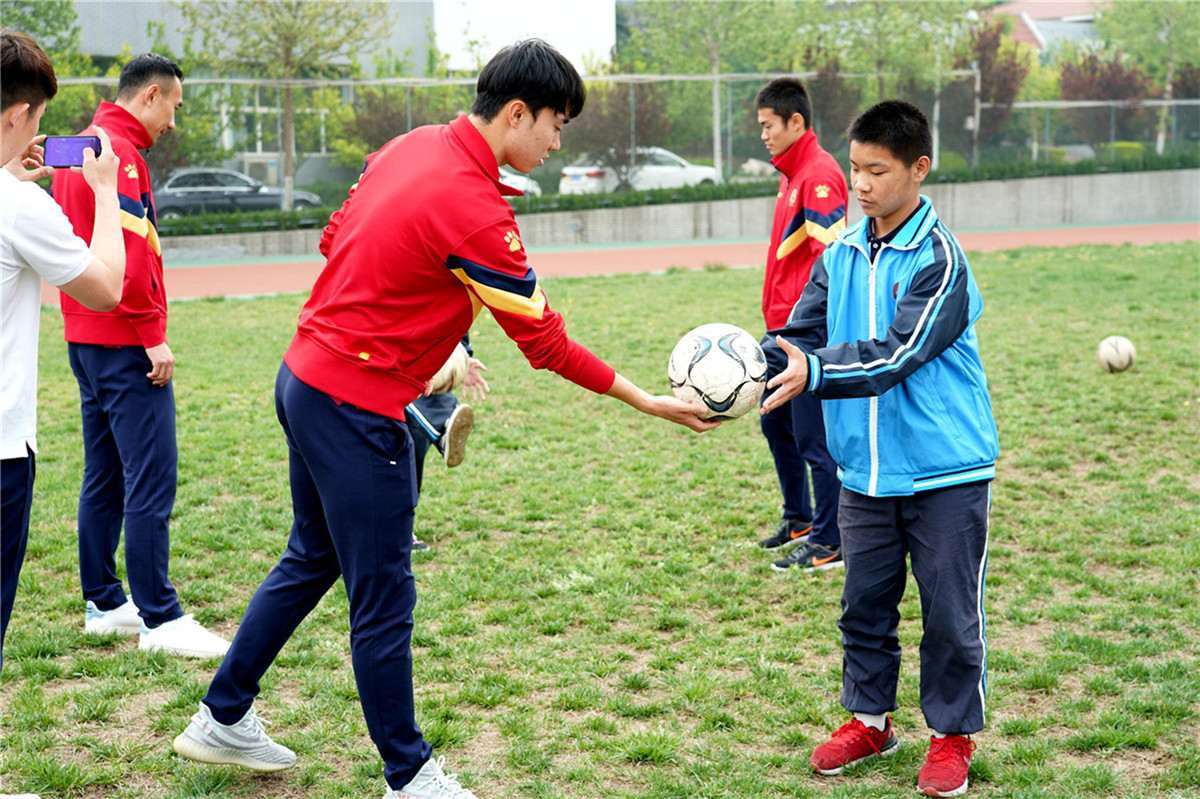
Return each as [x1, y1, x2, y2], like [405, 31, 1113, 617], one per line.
[175, 0, 390, 209]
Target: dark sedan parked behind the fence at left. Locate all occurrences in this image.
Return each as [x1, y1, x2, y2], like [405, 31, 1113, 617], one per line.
[154, 167, 320, 220]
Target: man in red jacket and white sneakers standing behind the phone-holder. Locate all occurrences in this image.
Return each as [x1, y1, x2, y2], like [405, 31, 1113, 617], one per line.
[53, 53, 229, 657]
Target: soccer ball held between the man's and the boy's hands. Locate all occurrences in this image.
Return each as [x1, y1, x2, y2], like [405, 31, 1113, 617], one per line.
[667, 323, 767, 419]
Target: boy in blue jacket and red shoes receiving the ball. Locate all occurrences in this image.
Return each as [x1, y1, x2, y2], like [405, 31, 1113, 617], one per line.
[763, 101, 998, 797]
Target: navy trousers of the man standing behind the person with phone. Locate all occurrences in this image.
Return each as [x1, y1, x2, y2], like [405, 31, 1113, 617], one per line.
[67, 343, 184, 627]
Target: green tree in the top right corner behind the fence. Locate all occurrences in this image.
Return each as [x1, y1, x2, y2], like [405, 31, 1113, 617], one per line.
[1096, 0, 1200, 155]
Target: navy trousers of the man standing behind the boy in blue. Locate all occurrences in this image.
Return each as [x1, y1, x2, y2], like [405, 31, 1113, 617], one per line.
[760, 334, 841, 549]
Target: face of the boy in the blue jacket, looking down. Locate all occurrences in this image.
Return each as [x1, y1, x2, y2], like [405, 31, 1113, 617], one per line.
[850, 142, 929, 236]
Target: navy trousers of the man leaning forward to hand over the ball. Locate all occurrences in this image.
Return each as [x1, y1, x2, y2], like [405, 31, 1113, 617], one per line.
[204, 364, 432, 788]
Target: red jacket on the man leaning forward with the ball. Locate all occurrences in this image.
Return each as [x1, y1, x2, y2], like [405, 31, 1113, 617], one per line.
[283, 116, 614, 420]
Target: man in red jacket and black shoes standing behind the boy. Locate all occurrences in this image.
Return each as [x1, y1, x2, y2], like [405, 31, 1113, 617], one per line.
[755, 78, 847, 571]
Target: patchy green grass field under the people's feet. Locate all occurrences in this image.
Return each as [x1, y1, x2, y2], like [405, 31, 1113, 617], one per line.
[0, 244, 1200, 799]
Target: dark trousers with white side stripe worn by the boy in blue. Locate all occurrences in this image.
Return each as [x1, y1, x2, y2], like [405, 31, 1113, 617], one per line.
[838, 482, 991, 735]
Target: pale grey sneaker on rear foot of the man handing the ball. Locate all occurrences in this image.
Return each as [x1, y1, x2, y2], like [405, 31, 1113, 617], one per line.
[174, 702, 296, 771]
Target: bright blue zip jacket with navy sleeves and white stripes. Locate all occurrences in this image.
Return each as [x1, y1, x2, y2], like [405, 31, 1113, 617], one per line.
[775, 196, 1000, 497]
